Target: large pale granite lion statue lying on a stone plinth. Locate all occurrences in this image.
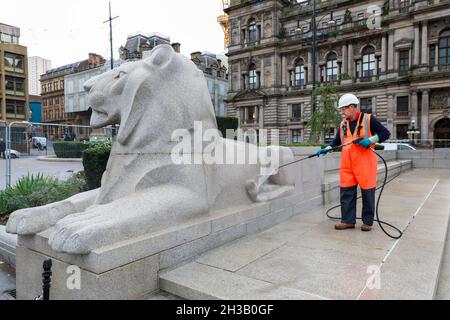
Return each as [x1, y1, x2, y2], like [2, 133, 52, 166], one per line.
[6, 45, 294, 254]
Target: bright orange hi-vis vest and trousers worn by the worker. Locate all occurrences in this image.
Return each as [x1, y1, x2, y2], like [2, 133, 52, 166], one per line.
[340, 113, 378, 190]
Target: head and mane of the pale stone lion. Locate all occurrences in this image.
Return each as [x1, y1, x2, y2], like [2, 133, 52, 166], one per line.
[85, 45, 217, 152]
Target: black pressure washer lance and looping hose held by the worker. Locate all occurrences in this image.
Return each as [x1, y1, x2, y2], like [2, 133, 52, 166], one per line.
[276, 138, 403, 239]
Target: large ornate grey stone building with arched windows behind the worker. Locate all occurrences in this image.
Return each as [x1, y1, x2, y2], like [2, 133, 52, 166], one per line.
[226, 0, 450, 147]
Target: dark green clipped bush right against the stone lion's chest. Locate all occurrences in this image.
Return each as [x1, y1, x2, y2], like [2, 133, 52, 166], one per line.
[82, 142, 111, 190]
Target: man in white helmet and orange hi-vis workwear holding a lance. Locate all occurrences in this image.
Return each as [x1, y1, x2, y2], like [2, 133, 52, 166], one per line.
[316, 94, 391, 231]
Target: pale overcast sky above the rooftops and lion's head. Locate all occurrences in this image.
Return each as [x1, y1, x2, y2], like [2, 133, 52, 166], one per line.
[0, 0, 229, 68]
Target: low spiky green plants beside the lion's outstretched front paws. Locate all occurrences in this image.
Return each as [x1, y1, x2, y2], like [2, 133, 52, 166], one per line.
[0, 174, 86, 224]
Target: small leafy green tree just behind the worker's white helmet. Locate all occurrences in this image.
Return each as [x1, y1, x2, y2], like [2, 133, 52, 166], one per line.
[308, 83, 341, 143]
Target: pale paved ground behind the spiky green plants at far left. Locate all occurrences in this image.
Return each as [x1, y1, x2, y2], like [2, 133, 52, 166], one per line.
[0, 156, 83, 190]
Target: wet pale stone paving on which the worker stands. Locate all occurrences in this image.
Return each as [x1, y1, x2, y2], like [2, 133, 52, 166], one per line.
[160, 169, 450, 300]
